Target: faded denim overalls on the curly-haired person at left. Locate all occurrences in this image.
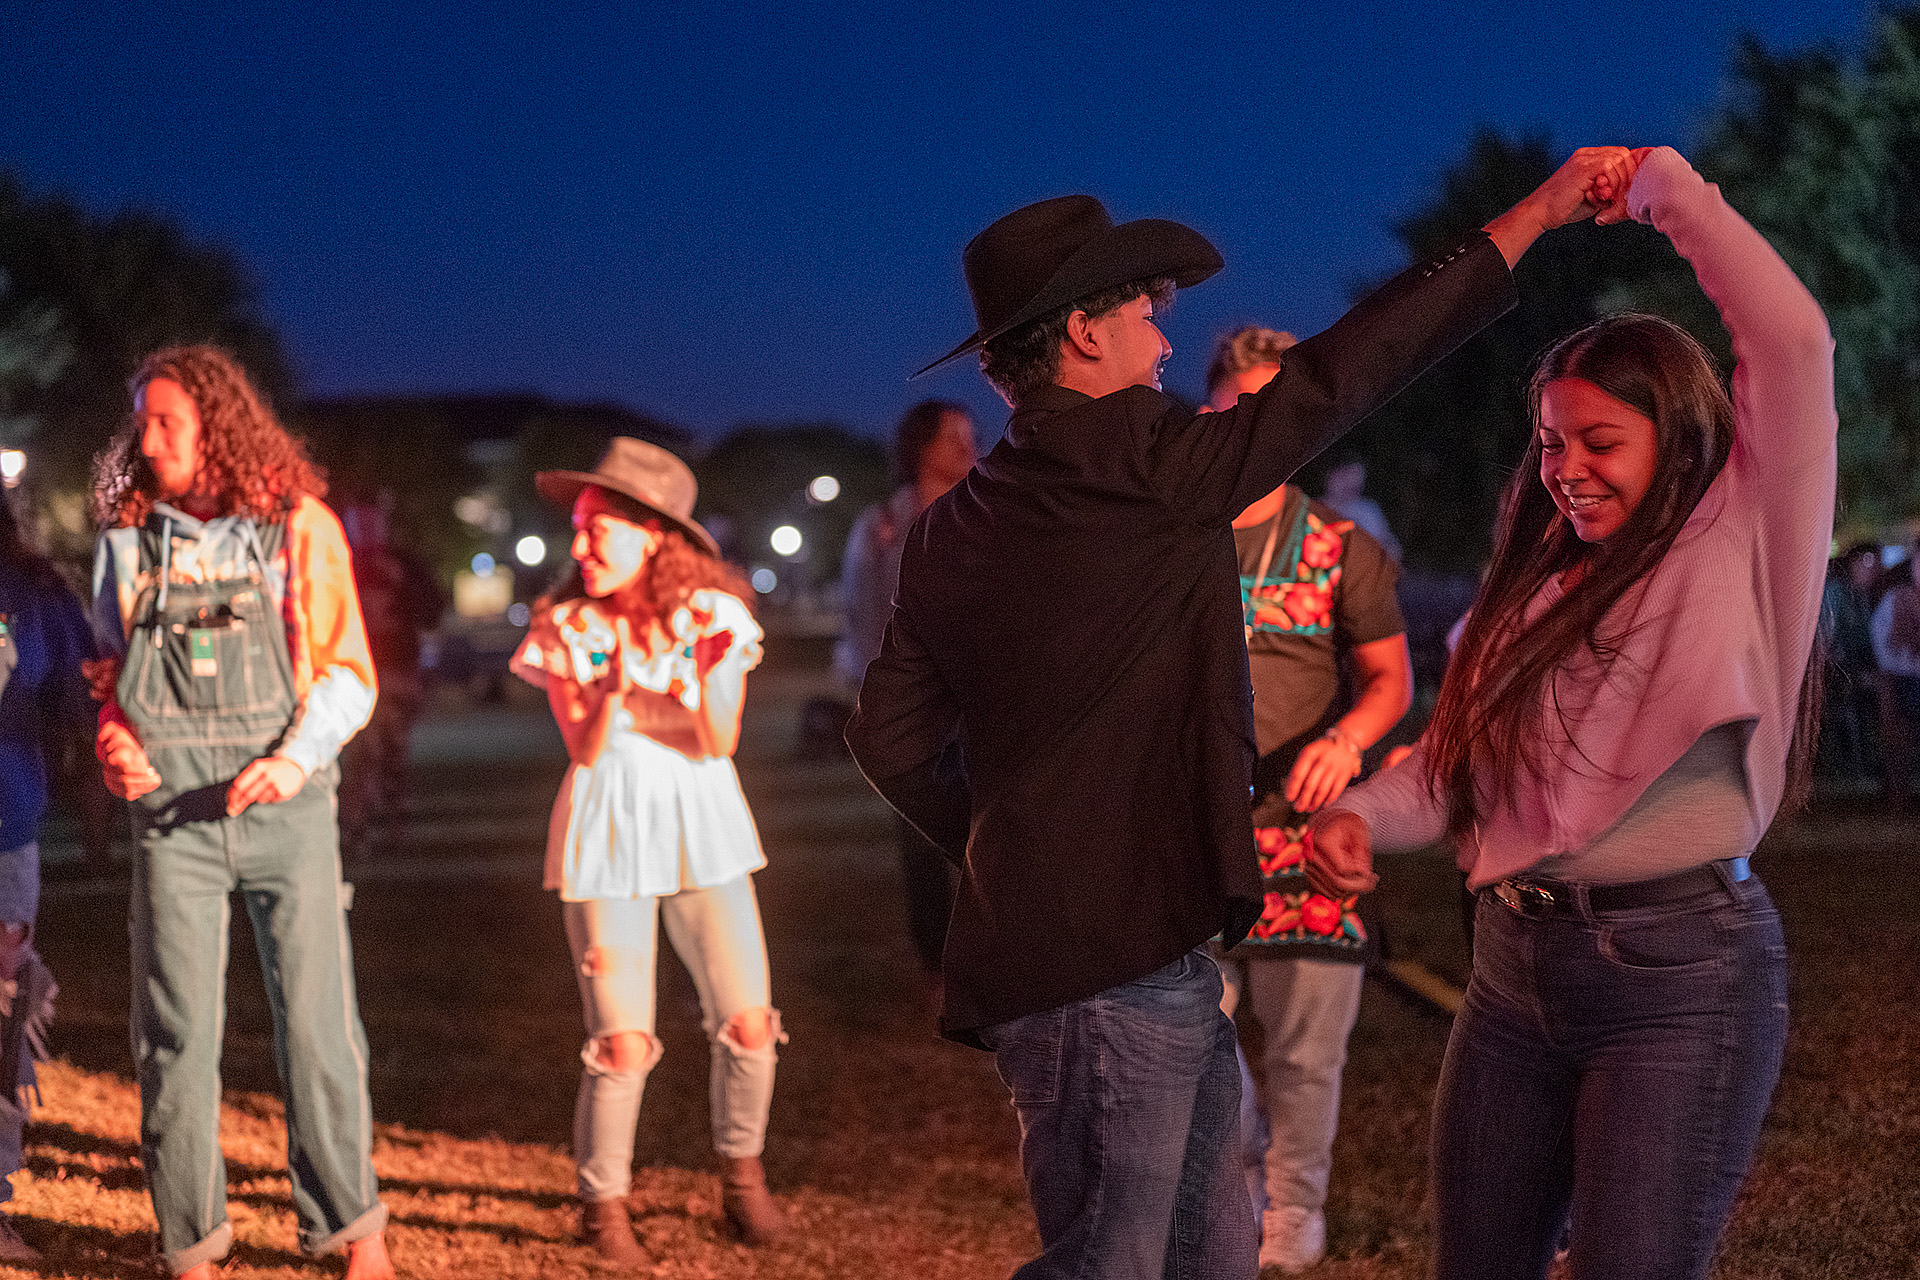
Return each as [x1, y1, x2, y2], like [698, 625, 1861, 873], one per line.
[117, 505, 386, 1274]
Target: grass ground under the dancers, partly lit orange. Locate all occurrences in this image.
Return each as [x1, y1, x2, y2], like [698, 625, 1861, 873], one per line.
[0, 670, 1920, 1280]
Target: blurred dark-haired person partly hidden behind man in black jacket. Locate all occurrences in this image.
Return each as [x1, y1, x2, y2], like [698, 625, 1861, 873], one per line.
[833, 399, 977, 977]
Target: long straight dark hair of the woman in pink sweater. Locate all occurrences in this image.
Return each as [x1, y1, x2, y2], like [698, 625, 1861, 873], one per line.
[1427, 315, 1766, 839]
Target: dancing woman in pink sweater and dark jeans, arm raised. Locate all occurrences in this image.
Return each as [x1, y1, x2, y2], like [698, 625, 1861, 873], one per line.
[1309, 148, 1836, 1280]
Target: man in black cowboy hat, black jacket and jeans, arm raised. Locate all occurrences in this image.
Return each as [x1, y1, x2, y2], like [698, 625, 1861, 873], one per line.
[847, 148, 1632, 1280]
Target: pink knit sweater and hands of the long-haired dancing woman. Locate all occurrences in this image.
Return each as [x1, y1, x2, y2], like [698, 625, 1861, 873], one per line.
[1327, 148, 1837, 887]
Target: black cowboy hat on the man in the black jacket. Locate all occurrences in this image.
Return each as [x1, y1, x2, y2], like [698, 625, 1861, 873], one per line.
[914, 196, 1225, 378]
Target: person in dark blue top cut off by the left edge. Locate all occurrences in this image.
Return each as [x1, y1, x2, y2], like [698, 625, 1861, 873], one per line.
[0, 493, 94, 1263]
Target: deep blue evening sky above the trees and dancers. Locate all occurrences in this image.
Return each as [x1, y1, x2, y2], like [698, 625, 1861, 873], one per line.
[0, 0, 1868, 438]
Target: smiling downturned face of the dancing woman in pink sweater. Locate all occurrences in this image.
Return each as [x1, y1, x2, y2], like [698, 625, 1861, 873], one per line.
[1538, 378, 1659, 543]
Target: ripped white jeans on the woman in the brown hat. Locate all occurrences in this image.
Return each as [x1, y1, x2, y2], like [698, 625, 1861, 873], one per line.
[563, 875, 785, 1199]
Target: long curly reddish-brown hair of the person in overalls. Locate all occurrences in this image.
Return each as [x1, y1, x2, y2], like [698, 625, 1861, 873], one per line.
[94, 344, 326, 526]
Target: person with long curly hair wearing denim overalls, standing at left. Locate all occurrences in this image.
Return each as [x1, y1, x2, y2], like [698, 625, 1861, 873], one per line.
[94, 345, 394, 1280]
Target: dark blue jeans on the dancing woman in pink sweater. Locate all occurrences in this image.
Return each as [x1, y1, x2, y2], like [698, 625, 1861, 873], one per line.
[1432, 877, 1788, 1280]
